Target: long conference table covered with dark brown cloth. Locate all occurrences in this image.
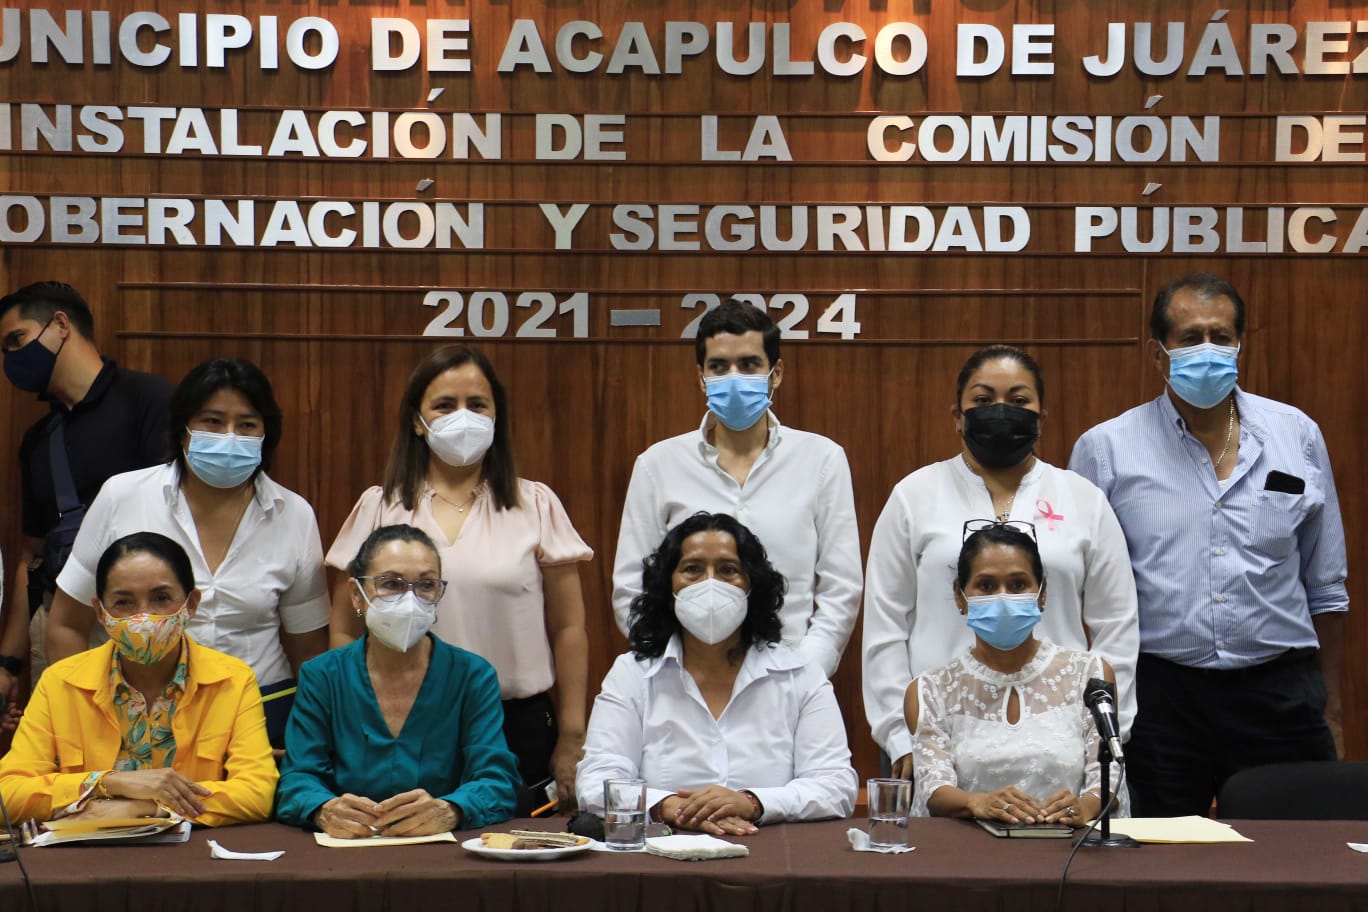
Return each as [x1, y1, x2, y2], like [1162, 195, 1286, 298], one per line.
[0, 819, 1368, 912]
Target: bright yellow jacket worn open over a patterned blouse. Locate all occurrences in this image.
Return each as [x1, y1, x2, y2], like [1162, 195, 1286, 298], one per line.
[0, 637, 279, 826]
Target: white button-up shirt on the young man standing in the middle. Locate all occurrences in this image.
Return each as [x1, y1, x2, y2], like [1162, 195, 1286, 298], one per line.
[613, 413, 863, 675]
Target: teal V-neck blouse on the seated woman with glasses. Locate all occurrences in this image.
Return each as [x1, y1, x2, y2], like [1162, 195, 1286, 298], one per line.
[276, 634, 518, 827]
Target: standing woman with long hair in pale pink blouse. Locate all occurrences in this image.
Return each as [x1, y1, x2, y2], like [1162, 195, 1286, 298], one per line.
[327, 345, 594, 816]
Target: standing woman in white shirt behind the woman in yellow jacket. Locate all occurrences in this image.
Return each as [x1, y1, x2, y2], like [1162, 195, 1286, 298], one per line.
[48, 358, 328, 749]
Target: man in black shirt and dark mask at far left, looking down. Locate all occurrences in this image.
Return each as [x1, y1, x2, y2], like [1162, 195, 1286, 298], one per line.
[0, 282, 171, 701]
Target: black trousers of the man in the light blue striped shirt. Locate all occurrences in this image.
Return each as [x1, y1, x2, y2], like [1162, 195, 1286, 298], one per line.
[1126, 651, 1335, 818]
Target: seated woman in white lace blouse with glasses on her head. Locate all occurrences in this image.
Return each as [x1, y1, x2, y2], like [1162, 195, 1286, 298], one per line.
[904, 520, 1115, 826]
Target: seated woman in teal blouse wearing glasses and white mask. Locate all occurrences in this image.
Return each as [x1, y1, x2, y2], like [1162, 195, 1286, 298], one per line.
[276, 525, 518, 838]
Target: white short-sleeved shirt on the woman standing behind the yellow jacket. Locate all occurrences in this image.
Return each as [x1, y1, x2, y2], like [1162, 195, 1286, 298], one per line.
[57, 462, 328, 686]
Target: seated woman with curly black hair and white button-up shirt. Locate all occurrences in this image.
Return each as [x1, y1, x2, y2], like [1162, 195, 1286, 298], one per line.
[576, 513, 858, 835]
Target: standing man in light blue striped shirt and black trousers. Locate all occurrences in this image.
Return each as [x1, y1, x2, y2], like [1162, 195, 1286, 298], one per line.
[1068, 273, 1349, 816]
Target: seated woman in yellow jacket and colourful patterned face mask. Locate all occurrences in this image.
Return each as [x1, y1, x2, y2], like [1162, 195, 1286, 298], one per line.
[0, 532, 278, 826]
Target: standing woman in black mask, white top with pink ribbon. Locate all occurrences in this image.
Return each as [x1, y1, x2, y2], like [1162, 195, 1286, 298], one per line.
[863, 345, 1140, 778]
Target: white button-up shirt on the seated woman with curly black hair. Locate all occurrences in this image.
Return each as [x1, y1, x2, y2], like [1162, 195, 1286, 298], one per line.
[575, 636, 859, 823]
